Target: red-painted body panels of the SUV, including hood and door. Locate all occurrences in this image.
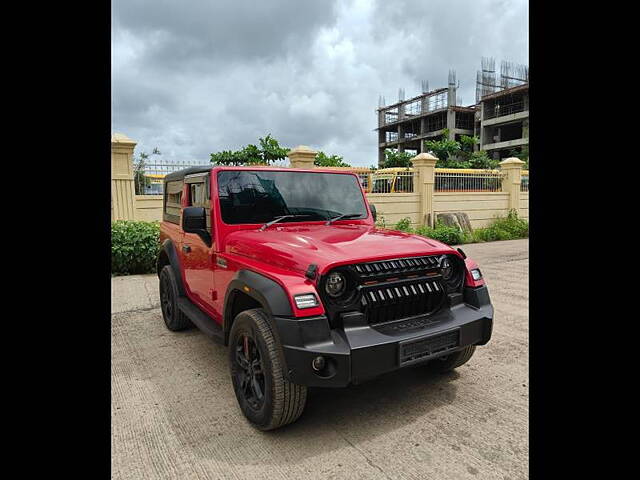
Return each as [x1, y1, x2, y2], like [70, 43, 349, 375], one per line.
[160, 167, 484, 323]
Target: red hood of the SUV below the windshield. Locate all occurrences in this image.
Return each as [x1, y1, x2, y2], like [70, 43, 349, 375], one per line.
[224, 225, 453, 274]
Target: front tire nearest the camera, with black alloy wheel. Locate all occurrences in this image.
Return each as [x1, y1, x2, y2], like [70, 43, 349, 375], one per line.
[229, 308, 307, 430]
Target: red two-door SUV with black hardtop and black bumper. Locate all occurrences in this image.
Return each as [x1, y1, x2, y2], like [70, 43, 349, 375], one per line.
[157, 166, 493, 430]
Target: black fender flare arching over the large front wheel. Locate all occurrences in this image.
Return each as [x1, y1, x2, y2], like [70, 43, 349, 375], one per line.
[224, 270, 293, 344]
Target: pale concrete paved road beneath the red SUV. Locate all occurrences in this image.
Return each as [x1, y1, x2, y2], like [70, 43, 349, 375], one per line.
[111, 240, 529, 480]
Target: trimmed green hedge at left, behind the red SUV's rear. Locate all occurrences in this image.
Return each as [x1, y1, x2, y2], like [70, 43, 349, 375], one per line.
[111, 220, 160, 275]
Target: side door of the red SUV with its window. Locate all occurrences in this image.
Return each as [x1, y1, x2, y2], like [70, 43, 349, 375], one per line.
[182, 173, 214, 313]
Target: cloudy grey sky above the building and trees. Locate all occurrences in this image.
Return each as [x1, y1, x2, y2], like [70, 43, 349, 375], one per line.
[111, 0, 529, 166]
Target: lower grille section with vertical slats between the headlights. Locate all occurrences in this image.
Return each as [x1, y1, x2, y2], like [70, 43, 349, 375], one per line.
[360, 277, 446, 324]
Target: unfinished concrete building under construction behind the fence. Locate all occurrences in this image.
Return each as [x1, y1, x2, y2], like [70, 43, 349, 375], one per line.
[376, 58, 529, 165]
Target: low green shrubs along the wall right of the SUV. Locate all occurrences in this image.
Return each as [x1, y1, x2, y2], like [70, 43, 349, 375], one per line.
[393, 210, 529, 245]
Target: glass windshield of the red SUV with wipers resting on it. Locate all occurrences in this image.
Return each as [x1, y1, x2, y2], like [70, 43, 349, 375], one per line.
[218, 170, 368, 224]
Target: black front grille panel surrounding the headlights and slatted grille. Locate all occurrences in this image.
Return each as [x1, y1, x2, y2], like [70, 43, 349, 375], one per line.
[319, 254, 464, 327]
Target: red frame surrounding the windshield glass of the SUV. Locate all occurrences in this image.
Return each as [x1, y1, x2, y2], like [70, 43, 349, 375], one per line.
[211, 166, 374, 230]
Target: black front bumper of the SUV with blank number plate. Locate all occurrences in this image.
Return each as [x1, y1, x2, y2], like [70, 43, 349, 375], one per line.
[274, 286, 493, 387]
